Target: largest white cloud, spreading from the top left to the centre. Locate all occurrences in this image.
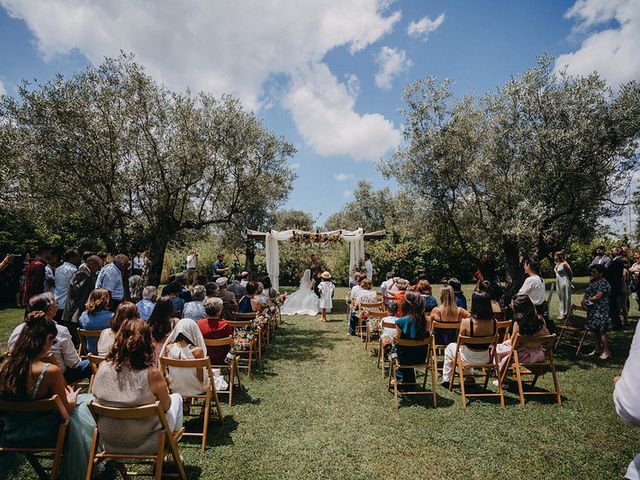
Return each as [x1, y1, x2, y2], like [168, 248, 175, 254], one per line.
[0, 0, 401, 158]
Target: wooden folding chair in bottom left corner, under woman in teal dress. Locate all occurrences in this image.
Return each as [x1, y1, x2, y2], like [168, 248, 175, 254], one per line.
[0, 395, 70, 480]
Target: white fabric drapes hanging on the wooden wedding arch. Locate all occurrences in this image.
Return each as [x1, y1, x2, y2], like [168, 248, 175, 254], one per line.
[265, 228, 364, 290]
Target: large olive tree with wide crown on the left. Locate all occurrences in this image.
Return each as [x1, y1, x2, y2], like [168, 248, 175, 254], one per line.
[0, 54, 295, 283]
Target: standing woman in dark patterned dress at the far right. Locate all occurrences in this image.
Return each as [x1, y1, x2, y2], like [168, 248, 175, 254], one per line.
[582, 263, 611, 360]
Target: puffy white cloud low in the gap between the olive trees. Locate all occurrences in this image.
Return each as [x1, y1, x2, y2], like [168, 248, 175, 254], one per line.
[283, 63, 401, 161]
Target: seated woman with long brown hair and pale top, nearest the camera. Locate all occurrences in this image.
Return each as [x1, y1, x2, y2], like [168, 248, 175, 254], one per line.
[93, 319, 182, 454]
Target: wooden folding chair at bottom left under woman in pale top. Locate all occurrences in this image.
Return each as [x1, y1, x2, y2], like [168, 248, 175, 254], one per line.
[86, 401, 187, 480]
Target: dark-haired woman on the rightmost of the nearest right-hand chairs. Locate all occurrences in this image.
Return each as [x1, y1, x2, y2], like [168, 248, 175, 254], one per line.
[496, 295, 549, 370]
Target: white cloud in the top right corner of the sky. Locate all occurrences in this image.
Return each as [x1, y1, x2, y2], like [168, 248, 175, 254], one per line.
[555, 0, 640, 88]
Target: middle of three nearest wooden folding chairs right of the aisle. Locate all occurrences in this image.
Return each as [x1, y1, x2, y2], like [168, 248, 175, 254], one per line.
[449, 334, 504, 409]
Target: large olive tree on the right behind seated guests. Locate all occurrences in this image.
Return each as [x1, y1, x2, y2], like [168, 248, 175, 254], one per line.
[381, 57, 640, 283]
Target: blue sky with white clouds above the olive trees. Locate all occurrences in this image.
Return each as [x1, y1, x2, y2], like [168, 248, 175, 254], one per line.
[0, 0, 640, 228]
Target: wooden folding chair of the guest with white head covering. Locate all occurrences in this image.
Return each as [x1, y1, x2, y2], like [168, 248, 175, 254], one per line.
[160, 357, 224, 453]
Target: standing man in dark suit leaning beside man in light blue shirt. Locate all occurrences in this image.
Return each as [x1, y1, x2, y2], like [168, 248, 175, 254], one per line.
[60, 255, 102, 344]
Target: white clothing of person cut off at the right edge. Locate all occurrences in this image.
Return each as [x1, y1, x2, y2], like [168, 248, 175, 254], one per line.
[613, 327, 640, 480]
